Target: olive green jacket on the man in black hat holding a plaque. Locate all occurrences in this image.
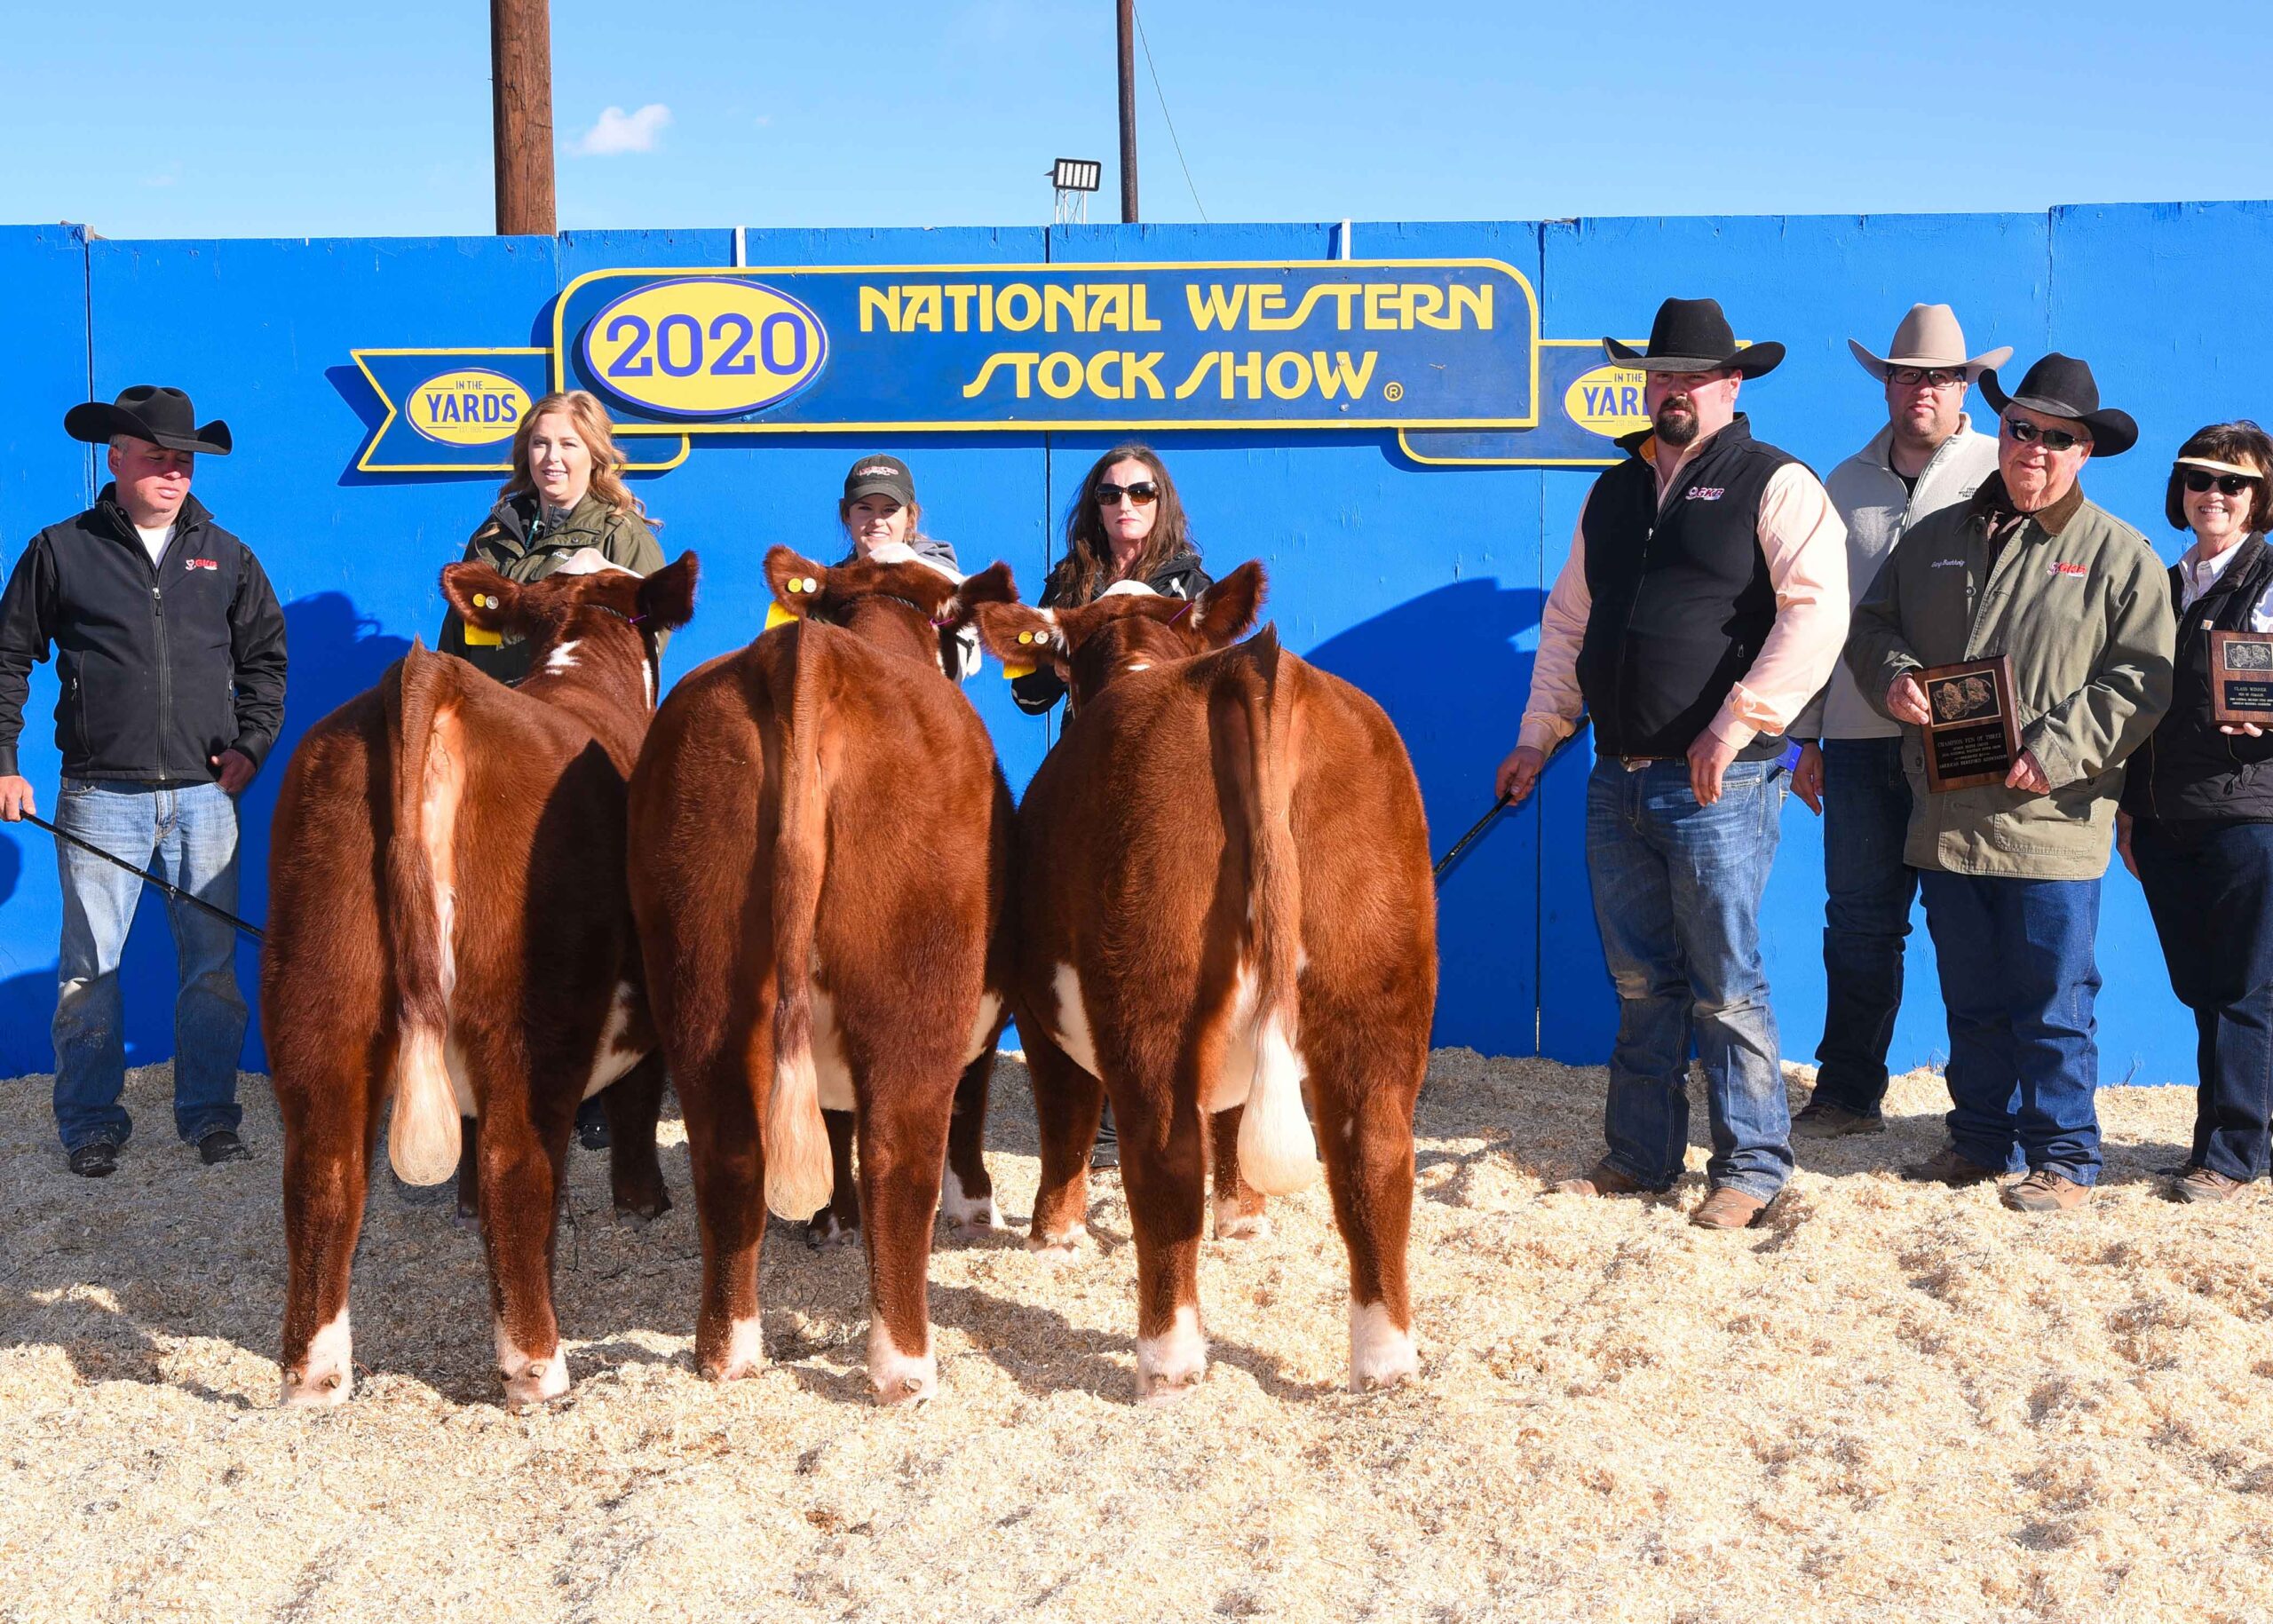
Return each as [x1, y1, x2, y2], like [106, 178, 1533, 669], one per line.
[1846, 475, 2177, 880]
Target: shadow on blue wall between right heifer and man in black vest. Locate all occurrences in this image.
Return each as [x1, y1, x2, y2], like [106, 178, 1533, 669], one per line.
[1307, 580, 1546, 1053]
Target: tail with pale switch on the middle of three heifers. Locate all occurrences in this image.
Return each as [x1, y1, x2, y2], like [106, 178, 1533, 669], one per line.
[766, 621, 836, 1219]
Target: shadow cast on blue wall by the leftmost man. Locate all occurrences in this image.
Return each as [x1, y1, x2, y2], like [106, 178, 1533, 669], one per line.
[0, 591, 409, 1072]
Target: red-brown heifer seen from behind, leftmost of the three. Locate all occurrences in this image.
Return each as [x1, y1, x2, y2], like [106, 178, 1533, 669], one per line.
[261, 548, 695, 1406]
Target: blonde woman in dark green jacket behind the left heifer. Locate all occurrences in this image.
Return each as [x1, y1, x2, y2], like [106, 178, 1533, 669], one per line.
[439, 389, 664, 682]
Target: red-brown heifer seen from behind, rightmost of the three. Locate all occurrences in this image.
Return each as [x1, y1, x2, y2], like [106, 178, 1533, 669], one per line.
[979, 564, 1437, 1401]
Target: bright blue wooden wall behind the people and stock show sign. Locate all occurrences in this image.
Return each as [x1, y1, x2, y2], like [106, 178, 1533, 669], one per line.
[0, 202, 2245, 1081]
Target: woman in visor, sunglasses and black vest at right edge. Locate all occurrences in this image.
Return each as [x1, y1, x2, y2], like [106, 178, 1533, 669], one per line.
[2116, 421, 2273, 1201]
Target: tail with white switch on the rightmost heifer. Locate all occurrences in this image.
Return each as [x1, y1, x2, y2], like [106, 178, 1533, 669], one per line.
[1239, 625, 1319, 1196]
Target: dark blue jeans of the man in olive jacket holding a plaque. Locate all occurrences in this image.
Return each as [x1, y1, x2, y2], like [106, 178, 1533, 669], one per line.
[1919, 869, 2100, 1185]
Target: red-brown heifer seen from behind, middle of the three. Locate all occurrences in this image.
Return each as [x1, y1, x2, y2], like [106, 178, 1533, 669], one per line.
[632, 546, 1016, 1404]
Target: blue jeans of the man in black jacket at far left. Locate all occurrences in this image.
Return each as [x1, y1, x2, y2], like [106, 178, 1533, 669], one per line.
[54, 778, 245, 1151]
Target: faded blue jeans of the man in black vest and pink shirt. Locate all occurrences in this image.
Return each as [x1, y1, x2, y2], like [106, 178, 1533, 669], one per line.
[1587, 757, 1791, 1201]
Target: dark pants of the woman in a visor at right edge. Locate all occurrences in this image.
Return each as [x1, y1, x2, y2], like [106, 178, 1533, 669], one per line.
[2132, 817, 2273, 1180]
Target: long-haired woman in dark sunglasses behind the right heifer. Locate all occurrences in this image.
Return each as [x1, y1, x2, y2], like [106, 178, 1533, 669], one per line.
[1010, 446, 1214, 717]
